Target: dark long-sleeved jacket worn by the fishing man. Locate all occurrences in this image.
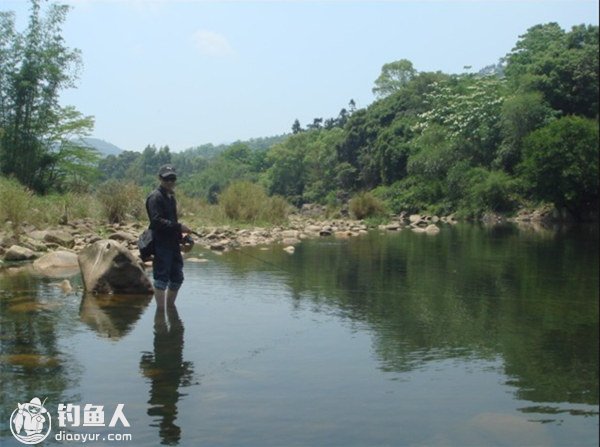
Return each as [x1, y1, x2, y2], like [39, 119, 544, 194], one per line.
[146, 186, 182, 246]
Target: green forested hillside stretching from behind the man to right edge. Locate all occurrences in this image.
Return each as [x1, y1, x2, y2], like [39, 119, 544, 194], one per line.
[92, 23, 598, 218]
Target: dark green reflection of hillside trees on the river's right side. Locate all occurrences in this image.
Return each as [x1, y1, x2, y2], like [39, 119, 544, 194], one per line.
[224, 225, 599, 414]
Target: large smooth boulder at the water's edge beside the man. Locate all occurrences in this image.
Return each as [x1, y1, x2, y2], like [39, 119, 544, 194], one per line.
[77, 239, 154, 294]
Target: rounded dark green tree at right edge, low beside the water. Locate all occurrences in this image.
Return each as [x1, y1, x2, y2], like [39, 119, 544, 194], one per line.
[520, 116, 599, 220]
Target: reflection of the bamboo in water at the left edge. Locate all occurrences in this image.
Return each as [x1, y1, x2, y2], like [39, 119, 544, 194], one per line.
[0, 267, 81, 436]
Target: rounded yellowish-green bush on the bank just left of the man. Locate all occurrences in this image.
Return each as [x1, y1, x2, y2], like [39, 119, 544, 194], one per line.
[96, 180, 145, 223]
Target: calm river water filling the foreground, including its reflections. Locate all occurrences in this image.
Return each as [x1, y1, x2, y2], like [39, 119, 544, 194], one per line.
[0, 225, 599, 446]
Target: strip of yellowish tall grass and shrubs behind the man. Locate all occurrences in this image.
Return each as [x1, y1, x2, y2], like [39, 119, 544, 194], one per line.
[0, 178, 290, 237]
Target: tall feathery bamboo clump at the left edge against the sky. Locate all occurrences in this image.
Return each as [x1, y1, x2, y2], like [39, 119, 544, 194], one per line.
[0, 0, 93, 192]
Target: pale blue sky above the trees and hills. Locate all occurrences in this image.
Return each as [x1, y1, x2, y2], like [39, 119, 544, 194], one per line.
[0, 0, 598, 151]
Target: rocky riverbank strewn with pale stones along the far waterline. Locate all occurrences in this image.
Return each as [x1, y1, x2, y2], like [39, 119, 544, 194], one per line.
[0, 203, 564, 270]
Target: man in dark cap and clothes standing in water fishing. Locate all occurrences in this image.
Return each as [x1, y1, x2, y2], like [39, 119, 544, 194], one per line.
[146, 164, 191, 307]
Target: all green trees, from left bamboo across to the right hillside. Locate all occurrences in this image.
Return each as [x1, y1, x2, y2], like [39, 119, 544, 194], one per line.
[0, 0, 598, 224]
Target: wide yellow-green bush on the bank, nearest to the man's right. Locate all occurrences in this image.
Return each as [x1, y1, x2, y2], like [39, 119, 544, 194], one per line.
[219, 181, 289, 223]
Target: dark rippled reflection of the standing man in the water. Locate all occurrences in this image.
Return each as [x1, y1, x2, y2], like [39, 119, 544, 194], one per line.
[140, 306, 193, 445]
